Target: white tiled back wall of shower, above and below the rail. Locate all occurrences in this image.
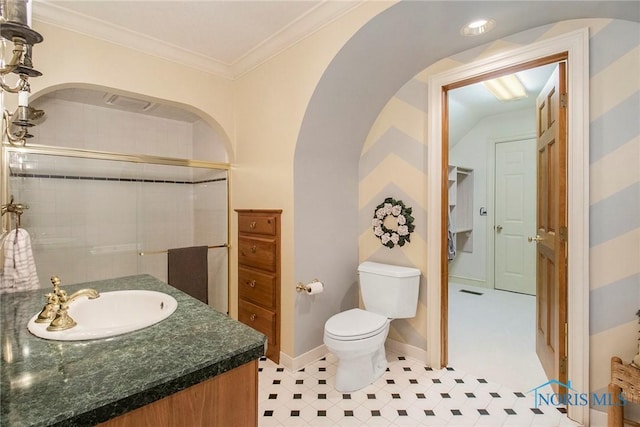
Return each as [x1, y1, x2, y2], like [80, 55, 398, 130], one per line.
[24, 100, 198, 286]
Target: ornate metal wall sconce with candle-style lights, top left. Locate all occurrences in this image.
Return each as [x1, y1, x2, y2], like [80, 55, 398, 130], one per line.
[0, 0, 44, 146]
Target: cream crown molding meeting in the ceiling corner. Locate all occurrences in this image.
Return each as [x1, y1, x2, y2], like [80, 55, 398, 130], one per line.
[32, 0, 365, 80]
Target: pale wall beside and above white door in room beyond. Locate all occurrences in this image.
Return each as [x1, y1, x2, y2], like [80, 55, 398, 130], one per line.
[449, 109, 536, 288]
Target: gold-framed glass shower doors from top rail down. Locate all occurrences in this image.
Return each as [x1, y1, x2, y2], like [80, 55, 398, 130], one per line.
[5, 148, 228, 313]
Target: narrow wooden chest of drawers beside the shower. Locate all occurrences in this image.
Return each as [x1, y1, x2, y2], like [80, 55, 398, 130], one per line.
[236, 209, 282, 363]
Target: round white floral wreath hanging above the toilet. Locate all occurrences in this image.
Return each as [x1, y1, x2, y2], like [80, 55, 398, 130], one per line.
[371, 197, 415, 249]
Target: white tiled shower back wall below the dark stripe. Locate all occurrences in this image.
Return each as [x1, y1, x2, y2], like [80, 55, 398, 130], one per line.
[12, 174, 194, 287]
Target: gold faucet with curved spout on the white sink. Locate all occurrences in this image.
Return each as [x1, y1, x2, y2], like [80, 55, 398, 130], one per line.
[36, 276, 100, 331]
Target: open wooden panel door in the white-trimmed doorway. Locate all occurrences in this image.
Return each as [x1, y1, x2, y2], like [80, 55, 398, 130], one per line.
[530, 62, 567, 391]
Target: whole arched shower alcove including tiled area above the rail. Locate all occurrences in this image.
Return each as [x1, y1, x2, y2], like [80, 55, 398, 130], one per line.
[0, 88, 229, 313]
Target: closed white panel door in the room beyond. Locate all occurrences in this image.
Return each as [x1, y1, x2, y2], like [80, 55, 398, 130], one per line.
[494, 139, 536, 295]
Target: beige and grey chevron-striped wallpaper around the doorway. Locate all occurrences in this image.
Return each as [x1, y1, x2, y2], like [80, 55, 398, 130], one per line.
[358, 19, 640, 398]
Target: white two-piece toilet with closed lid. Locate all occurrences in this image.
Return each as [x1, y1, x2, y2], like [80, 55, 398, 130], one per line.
[324, 262, 420, 392]
